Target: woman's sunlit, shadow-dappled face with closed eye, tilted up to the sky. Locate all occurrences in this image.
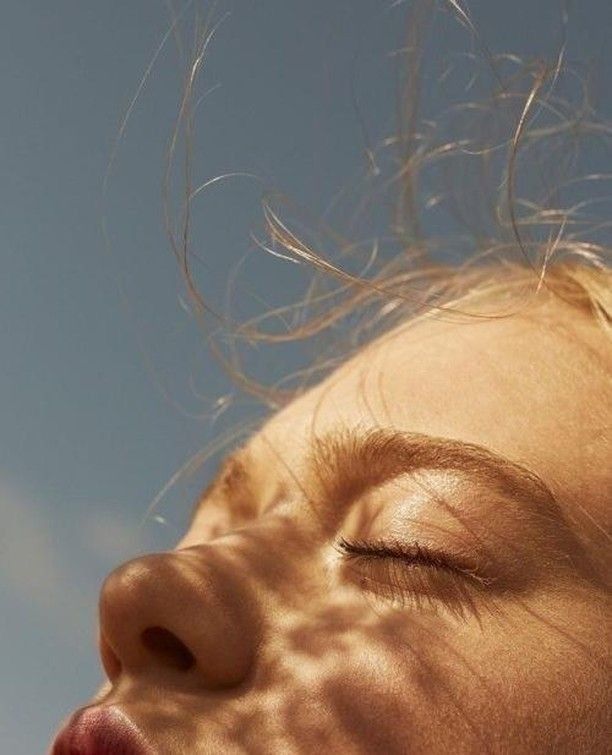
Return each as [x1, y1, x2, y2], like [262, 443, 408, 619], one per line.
[51, 300, 612, 755]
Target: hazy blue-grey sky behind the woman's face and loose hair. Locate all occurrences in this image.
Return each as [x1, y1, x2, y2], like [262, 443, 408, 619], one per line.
[0, 0, 612, 755]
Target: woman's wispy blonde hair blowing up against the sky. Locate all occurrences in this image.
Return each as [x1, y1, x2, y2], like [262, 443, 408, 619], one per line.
[159, 0, 612, 426]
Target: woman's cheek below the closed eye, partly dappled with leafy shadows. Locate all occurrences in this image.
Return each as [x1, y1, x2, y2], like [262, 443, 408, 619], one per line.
[262, 595, 605, 753]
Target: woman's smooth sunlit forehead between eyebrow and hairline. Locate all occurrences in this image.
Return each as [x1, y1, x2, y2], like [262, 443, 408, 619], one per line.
[252, 302, 612, 516]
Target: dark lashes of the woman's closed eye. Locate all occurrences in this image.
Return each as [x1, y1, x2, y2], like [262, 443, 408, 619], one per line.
[336, 538, 491, 618]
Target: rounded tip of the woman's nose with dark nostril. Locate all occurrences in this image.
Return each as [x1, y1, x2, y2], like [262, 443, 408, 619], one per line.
[99, 545, 261, 689]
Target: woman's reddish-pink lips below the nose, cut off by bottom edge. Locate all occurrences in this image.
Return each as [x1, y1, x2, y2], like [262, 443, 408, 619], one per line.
[49, 706, 153, 755]
